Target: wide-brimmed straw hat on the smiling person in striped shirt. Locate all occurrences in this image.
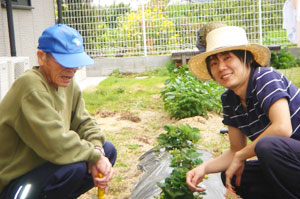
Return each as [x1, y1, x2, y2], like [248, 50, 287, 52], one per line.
[188, 26, 271, 81]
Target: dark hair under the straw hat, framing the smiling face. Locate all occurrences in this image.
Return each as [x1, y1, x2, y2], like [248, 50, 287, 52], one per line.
[205, 50, 260, 77]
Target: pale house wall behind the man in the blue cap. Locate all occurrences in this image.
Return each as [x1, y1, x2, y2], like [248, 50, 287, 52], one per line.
[0, 0, 55, 65]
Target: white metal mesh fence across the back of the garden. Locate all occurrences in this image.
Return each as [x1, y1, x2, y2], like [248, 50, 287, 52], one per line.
[62, 0, 290, 57]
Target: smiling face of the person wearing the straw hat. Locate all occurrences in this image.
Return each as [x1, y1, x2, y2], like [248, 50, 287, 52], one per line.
[208, 51, 250, 93]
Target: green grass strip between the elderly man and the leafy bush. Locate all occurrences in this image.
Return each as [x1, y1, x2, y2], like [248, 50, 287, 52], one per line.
[83, 69, 168, 113]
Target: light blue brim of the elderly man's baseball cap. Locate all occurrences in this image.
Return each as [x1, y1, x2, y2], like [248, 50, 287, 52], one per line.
[51, 52, 94, 68]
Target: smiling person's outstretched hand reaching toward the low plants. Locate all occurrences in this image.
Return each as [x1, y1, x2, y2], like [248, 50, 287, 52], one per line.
[186, 165, 206, 192]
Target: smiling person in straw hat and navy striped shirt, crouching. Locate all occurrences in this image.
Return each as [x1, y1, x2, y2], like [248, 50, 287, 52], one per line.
[186, 26, 300, 198]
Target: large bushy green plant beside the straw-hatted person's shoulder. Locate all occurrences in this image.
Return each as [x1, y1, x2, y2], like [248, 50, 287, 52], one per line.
[161, 65, 224, 119]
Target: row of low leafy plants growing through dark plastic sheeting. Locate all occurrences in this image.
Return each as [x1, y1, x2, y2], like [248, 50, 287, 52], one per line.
[156, 124, 202, 199]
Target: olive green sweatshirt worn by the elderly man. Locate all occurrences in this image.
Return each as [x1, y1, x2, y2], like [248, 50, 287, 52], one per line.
[0, 68, 105, 193]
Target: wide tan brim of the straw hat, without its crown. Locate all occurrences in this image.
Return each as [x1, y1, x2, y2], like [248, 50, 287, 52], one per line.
[188, 44, 271, 81]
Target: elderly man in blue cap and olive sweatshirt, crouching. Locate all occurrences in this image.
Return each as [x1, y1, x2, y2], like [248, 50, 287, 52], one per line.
[0, 24, 117, 199]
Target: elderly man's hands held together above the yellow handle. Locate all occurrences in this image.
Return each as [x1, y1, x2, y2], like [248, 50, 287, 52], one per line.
[89, 155, 114, 192]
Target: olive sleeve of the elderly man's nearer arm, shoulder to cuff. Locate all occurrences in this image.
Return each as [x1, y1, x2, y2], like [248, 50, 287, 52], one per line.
[14, 91, 101, 164]
